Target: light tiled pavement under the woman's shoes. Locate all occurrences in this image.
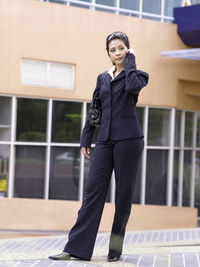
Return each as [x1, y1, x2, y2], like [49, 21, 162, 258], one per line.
[0, 228, 200, 267]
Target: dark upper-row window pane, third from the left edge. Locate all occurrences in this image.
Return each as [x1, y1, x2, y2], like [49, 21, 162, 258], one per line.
[52, 101, 82, 143]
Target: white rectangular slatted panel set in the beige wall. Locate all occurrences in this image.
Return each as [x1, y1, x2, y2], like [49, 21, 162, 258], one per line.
[21, 59, 74, 89]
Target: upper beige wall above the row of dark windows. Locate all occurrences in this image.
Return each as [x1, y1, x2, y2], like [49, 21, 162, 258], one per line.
[0, 0, 200, 110]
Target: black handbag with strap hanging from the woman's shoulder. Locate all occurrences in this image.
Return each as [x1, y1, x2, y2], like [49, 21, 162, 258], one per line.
[88, 71, 107, 127]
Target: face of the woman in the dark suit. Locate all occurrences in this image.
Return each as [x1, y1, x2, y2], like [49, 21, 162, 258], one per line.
[108, 39, 128, 65]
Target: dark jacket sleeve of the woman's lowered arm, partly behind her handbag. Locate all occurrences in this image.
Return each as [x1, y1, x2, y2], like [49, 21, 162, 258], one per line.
[80, 74, 101, 148]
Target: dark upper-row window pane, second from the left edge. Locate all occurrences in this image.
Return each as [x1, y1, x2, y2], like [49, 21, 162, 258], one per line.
[17, 98, 47, 142]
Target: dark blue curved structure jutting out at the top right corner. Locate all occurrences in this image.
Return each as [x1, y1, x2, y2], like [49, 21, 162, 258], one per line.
[174, 4, 200, 47]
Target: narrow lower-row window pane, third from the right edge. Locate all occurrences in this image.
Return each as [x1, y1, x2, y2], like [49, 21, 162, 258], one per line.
[172, 150, 180, 206]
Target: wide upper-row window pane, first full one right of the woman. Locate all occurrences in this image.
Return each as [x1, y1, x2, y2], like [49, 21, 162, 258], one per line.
[148, 108, 170, 146]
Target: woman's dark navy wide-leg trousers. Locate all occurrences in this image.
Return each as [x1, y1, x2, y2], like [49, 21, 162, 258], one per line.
[64, 138, 144, 260]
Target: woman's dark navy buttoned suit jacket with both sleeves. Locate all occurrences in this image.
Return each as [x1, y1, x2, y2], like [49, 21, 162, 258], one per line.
[80, 53, 149, 147]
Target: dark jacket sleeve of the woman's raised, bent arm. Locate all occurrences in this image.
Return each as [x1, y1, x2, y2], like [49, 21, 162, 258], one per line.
[124, 53, 149, 95]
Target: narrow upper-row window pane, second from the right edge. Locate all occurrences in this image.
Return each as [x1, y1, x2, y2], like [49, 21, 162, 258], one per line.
[185, 112, 194, 147]
